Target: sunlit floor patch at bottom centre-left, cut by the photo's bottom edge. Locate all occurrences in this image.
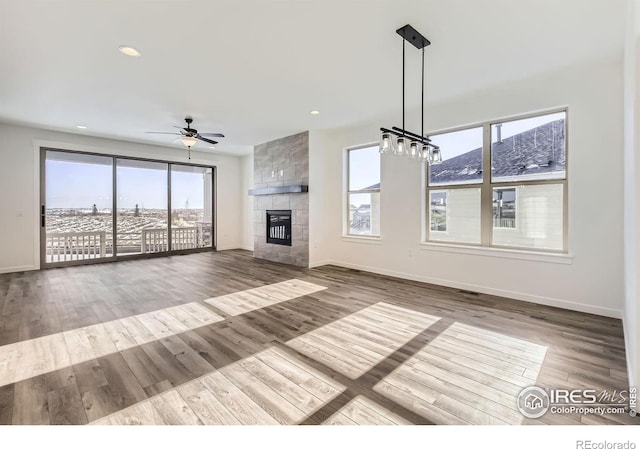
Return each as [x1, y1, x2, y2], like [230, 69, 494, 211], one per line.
[93, 347, 345, 425]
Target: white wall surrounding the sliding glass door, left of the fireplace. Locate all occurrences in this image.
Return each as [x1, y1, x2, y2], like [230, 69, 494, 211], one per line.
[0, 124, 242, 273]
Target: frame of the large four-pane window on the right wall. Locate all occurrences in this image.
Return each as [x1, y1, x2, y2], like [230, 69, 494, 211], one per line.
[423, 106, 569, 255]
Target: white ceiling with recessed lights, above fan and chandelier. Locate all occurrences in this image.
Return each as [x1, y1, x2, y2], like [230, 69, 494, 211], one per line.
[0, 0, 626, 154]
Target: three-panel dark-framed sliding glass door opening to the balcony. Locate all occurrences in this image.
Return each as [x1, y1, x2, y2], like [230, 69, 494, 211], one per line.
[40, 149, 214, 266]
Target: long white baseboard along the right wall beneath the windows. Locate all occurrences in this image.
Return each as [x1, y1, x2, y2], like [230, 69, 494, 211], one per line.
[322, 260, 622, 319]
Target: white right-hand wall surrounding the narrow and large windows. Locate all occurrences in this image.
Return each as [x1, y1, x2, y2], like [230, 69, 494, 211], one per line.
[310, 56, 624, 317]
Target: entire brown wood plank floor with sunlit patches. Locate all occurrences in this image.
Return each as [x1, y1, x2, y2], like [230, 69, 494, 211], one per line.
[0, 250, 638, 425]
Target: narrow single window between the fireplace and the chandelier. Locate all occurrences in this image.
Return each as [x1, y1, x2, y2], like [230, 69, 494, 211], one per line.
[346, 145, 380, 237]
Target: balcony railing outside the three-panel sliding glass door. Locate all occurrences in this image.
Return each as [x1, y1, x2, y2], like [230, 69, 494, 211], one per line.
[46, 223, 212, 263]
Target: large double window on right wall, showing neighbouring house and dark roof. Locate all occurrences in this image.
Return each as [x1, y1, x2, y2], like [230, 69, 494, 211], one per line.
[427, 110, 567, 251]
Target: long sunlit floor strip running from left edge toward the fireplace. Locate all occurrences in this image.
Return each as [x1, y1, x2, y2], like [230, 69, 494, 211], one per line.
[0, 279, 326, 386]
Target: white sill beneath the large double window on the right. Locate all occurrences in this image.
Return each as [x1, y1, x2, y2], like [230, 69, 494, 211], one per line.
[420, 242, 573, 265]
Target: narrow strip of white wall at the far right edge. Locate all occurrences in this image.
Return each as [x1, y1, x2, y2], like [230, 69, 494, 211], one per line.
[624, 0, 640, 386]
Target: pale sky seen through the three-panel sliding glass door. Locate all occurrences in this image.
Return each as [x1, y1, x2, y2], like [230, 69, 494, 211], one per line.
[46, 160, 204, 209]
